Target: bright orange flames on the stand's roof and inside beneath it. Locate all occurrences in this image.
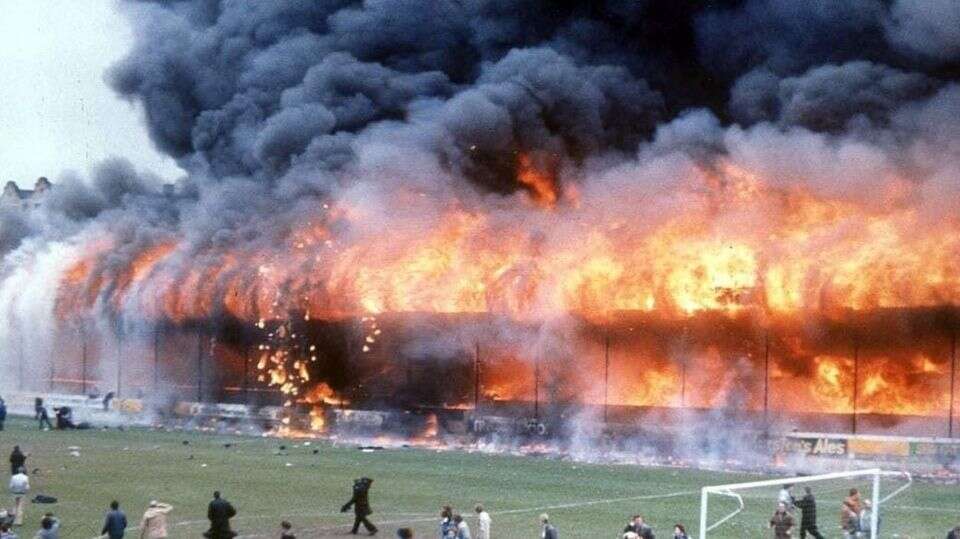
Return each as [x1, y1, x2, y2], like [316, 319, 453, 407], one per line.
[56, 158, 960, 420]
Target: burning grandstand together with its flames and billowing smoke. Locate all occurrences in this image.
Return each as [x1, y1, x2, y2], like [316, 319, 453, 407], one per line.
[0, 2, 960, 450]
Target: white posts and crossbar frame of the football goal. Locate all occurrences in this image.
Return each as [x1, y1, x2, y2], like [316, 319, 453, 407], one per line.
[700, 468, 913, 539]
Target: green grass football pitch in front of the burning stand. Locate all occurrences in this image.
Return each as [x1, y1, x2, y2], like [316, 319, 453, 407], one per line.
[0, 420, 960, 539]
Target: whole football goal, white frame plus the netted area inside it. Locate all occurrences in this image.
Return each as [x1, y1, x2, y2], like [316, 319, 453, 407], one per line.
[699, 468, 913, 539]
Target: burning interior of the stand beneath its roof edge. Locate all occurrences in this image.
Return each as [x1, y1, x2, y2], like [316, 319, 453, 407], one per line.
[46, 309, 960, 435]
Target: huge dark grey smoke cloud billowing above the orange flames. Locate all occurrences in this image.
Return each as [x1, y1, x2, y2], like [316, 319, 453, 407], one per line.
[0, 0, 960, 400]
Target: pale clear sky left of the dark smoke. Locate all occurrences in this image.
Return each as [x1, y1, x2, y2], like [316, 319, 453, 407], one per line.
[0, 0, 182, 188]
